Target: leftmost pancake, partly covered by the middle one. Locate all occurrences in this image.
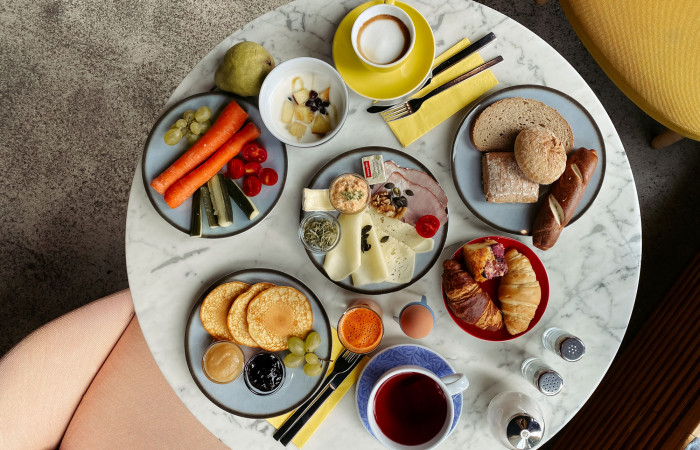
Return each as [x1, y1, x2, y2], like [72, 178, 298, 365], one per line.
[199, 281, 250, 340]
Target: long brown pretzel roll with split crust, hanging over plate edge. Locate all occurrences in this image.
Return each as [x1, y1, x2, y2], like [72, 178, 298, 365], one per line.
[532, 147, 598, 250]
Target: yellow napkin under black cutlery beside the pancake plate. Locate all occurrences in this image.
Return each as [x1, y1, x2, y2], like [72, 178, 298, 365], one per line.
[267, 328, 369, 448]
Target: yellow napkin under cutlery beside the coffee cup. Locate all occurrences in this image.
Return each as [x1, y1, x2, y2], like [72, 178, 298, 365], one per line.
[388, 38, 498, 147]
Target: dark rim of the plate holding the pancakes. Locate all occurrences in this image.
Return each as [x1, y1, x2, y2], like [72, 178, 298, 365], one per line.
[184, 267, 333, 419]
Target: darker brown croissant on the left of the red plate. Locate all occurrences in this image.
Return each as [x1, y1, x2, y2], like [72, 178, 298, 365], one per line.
[442, 259, 503, 331]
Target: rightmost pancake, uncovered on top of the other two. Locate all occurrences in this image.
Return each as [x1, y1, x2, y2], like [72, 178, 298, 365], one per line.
[247, 286, 314, 352]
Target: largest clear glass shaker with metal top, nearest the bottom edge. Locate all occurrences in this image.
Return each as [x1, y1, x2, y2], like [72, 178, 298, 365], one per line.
[486, 392, 544, 449]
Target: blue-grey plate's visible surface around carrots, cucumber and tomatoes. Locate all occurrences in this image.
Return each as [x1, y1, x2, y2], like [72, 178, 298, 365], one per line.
[141, 92, 287, 238]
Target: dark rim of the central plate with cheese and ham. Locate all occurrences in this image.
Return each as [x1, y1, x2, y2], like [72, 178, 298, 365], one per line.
[299, 145, 450, 295]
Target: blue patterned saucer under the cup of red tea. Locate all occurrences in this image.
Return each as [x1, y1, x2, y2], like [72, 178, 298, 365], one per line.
[355, 344, 462, 437]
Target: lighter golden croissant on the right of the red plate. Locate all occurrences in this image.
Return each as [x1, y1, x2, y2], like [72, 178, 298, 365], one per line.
[498, 248, 542, 334]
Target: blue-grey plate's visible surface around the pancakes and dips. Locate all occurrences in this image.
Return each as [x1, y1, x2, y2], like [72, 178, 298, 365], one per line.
[185, 269, 333, 419]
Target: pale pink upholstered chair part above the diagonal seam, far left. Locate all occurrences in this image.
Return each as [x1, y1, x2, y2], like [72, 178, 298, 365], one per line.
[0, 291, 134, 449]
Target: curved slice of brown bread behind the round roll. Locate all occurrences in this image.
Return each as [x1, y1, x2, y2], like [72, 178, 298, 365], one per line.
[471, 97, 574, 153]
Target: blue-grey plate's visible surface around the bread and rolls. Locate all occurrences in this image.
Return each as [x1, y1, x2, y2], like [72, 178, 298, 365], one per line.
[452, 85, 606, 236]
